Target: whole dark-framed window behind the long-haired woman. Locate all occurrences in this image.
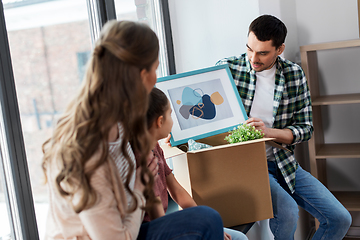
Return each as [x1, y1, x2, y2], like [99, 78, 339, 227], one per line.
[0, 0, 172, 240]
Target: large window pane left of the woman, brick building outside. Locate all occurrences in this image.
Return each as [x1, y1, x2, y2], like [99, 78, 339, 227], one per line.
[0, 0, 92, 239]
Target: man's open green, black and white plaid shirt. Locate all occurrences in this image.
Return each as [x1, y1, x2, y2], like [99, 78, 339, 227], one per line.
[216, 53, 314, 192]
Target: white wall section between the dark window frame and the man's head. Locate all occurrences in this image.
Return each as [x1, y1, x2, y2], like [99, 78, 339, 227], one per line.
[169, 0, 259, 73]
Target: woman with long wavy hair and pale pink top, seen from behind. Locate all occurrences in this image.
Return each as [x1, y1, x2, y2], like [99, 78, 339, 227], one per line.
[43, 21, 223, 239]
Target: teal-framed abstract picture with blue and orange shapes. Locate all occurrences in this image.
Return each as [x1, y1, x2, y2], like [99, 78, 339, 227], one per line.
[155, 64, 247, 146]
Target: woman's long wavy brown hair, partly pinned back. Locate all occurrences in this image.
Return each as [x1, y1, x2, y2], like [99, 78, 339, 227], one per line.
[42, 20, 159, 213]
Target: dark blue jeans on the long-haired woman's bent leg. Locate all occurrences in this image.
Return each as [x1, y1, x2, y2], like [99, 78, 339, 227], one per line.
[137, 206, 224, 240]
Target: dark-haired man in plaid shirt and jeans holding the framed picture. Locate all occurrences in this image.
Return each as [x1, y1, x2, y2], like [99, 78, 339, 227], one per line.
[217, 15, 351, 240]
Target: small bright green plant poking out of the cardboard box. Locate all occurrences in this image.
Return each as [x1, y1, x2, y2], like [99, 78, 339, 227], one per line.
[225, 124, 264, 143]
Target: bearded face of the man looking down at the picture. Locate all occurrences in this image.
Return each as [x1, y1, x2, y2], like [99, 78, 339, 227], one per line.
[246, 32, 285, 72]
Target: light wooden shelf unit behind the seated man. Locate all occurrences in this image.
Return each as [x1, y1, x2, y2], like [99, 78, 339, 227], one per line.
[300, 39, 360, 234]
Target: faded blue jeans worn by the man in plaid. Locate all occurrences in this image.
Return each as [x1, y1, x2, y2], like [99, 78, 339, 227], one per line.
[268, 161, 351, 240]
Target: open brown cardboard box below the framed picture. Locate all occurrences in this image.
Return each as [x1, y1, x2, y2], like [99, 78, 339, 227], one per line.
[163, 133, 281, 227]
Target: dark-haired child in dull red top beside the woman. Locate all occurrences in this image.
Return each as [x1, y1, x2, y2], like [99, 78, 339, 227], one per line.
[144, 88, 247, 240]
